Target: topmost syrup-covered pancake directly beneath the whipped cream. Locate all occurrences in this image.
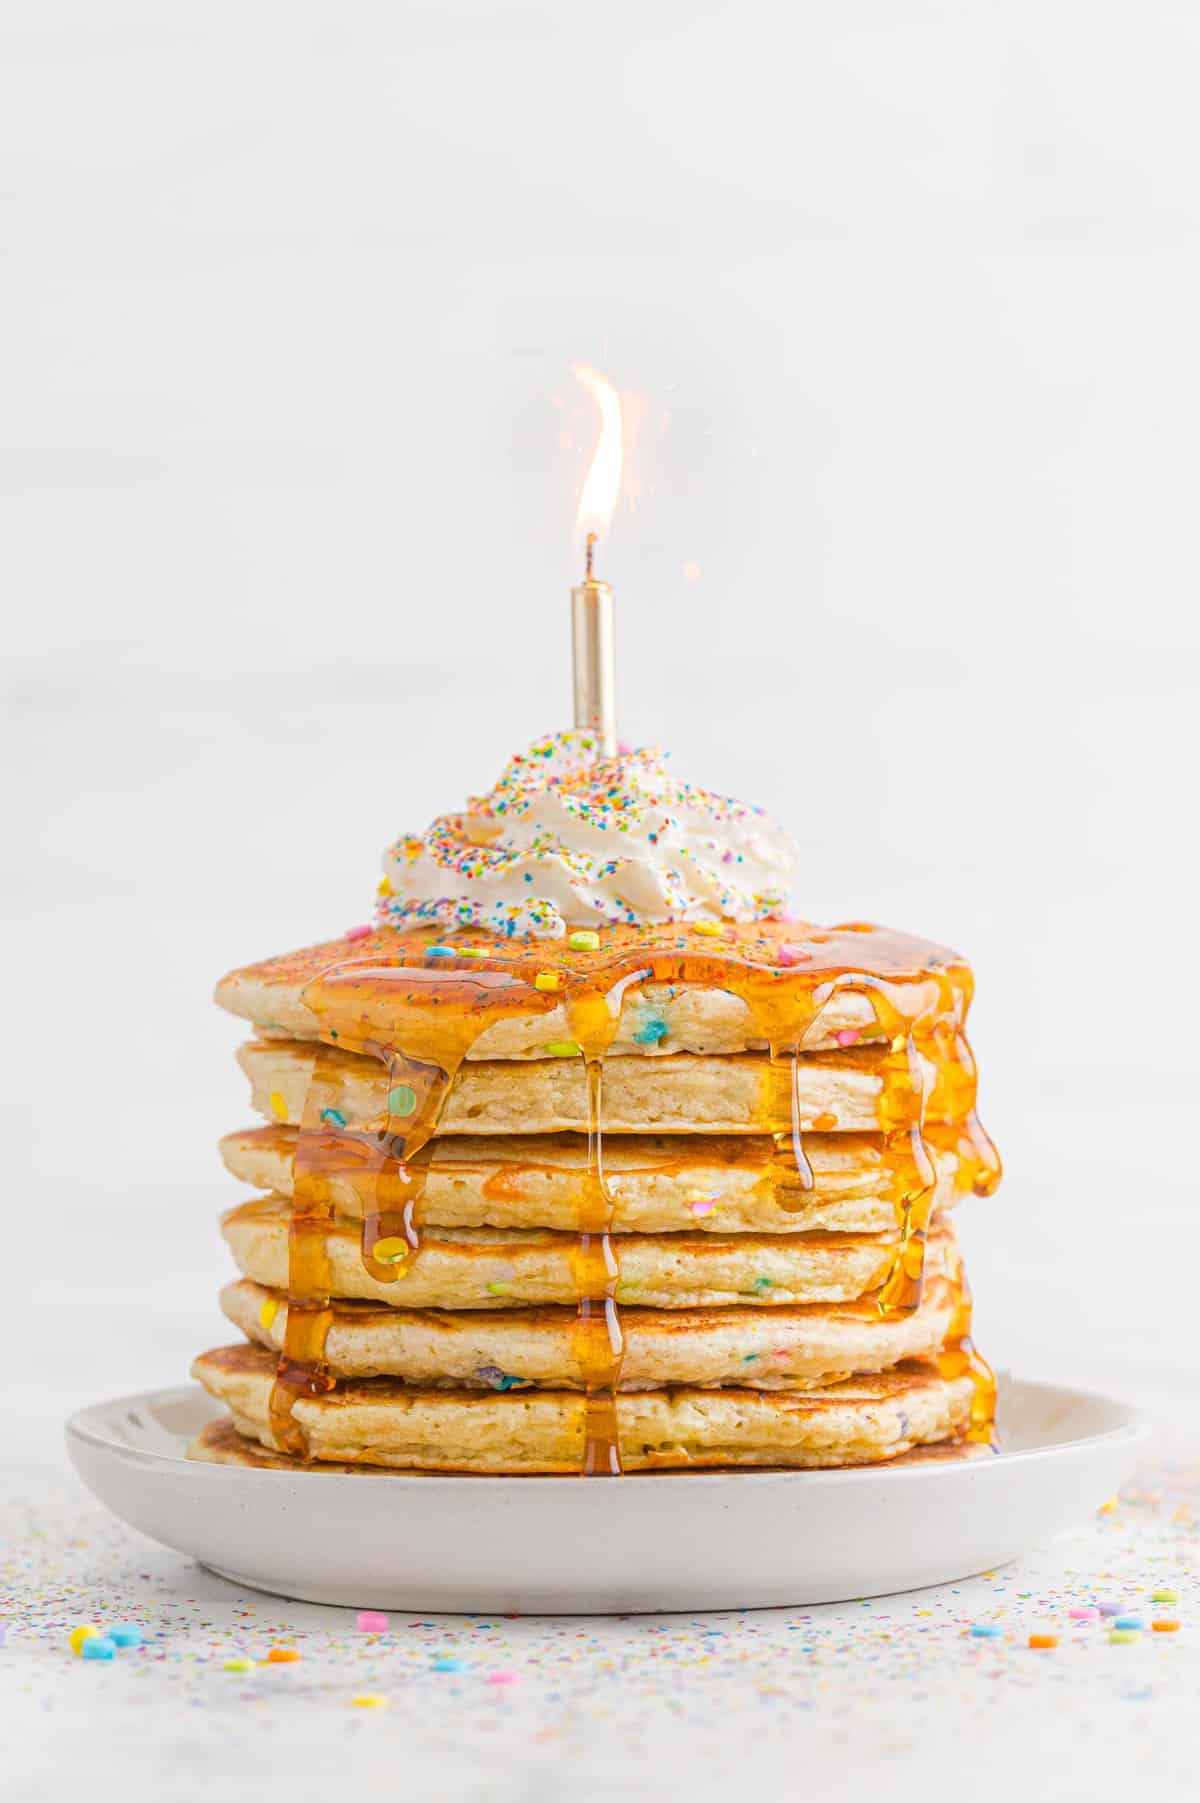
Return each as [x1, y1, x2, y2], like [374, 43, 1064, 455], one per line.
[216, 921, 973, 1060]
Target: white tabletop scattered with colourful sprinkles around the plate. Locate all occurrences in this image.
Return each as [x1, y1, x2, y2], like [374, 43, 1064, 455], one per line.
[0, 1427, 1200, 1803]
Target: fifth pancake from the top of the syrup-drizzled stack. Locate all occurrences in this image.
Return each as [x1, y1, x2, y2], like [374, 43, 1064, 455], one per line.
[222, 1257, 960, 1392]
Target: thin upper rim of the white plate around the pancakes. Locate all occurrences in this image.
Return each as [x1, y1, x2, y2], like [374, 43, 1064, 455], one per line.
[63, 1372, 1153, 1493]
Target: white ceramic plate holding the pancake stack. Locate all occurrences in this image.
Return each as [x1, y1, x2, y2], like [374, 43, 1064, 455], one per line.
[67, 1379, 1146, 1614]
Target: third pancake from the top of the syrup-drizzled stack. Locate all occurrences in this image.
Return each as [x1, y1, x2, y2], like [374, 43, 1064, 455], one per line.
[220, 1125, 973, 1233]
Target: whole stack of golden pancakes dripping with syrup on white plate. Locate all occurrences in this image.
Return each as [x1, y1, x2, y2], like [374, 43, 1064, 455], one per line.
[191, 921, 998, 1473]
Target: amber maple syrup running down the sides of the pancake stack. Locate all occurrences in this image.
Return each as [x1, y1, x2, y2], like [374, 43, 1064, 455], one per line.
[270, 925, 998, 1475]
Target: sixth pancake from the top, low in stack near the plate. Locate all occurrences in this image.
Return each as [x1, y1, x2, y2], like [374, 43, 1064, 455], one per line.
[191, 1345, 973, 1473]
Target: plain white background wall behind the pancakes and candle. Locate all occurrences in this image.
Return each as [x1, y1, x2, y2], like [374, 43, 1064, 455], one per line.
[0, 0, 1200, 1468]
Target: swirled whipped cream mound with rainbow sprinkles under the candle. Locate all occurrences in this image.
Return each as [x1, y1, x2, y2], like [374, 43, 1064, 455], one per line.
[378, 732, 796, 939]
